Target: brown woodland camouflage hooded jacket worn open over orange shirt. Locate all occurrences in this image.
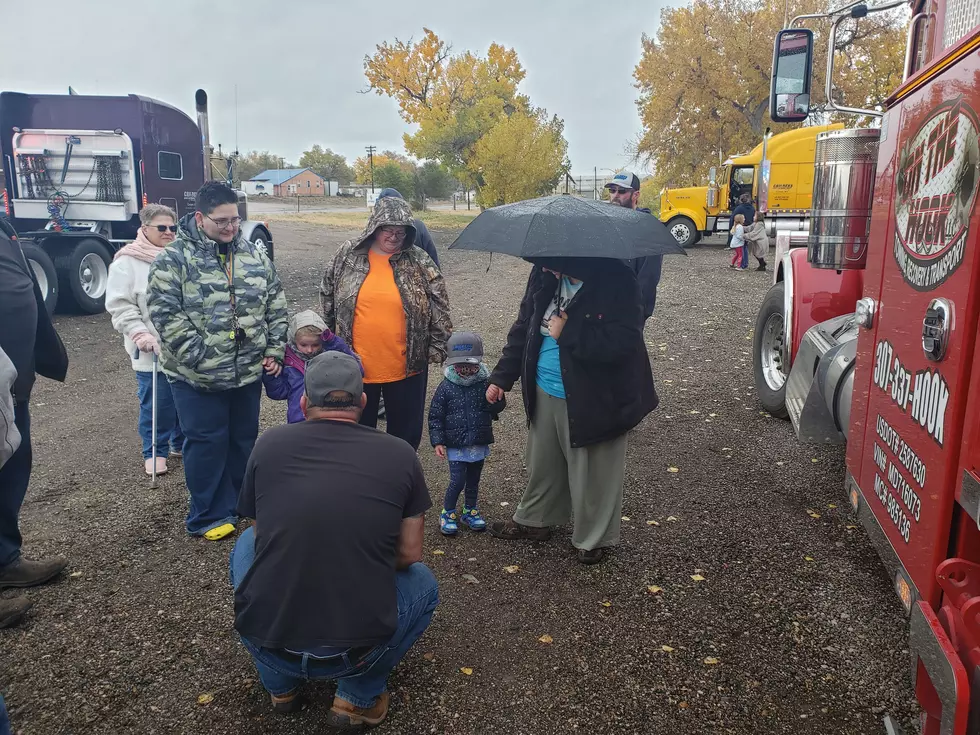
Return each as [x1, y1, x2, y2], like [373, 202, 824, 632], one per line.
[320, 197, 453, 374]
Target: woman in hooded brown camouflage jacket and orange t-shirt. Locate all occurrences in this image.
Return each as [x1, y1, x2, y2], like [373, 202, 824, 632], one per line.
[320, 197, 452, 449]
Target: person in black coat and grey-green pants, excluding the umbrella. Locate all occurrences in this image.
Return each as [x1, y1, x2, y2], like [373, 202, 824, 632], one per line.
[487, 258, 657, 564]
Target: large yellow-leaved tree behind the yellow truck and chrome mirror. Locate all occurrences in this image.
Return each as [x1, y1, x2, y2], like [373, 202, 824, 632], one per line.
[634, 0, 905, 186]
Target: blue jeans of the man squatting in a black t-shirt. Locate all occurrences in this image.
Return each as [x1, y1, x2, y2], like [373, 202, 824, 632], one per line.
[231, 528, 439, 708]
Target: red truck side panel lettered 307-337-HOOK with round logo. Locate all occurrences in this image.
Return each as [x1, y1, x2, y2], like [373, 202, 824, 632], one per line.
[847, 64, 980, 607]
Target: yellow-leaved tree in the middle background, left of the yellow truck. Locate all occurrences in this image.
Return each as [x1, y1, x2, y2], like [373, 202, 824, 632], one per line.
[364, 28, 567, 202]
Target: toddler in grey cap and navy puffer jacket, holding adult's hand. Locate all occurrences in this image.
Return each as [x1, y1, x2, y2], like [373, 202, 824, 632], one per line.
[429, 332, 506, 536]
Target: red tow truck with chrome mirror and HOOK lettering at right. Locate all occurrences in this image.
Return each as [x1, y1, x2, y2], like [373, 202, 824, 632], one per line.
[755, 0, 980, 735]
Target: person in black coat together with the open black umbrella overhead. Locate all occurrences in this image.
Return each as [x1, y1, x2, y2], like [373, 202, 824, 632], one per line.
[452, 196, 672, 564]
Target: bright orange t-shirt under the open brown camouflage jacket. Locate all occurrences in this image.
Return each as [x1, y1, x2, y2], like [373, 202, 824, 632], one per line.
[352, 250, 408, 383]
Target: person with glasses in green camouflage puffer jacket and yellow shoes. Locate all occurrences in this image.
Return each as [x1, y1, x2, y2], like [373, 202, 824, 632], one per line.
[147, 182, 289, 541]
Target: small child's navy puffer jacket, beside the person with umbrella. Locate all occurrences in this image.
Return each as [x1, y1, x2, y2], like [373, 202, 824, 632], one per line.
[429, 378, 505, 449]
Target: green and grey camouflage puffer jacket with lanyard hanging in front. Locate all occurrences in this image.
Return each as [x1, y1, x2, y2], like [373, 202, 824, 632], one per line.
[146, 215, 289, 391]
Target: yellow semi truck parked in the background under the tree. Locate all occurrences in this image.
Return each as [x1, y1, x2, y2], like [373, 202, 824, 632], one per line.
[660, 123, 844, 247]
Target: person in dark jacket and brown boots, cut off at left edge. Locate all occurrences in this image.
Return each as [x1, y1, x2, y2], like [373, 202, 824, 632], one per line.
[0, 221, 68, 628]
